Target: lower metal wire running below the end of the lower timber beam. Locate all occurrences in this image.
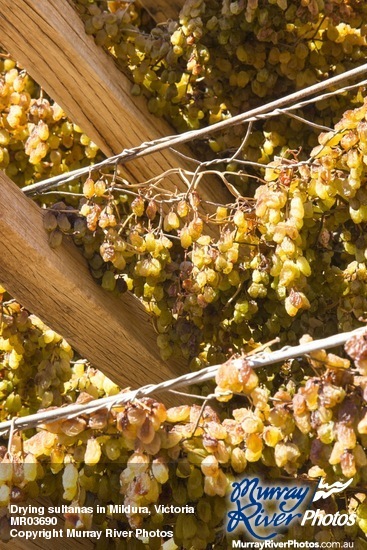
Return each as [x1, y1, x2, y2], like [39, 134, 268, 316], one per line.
[0, 327, 367, 435]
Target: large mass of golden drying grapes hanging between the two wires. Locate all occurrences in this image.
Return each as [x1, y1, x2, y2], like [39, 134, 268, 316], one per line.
[41, 98, 367, 380]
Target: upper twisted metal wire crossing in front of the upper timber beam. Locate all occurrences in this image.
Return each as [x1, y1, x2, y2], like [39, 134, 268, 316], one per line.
[22, 69, 367, 195]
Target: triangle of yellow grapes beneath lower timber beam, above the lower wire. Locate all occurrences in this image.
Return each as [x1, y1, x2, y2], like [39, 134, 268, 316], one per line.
[0, 292, 119, 421]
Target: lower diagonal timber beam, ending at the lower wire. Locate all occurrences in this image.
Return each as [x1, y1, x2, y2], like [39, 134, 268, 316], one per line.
[0, 172, 185, 394]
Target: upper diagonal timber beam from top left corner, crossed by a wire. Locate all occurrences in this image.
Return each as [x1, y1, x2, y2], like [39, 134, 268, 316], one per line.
[0, 0, 230, 206]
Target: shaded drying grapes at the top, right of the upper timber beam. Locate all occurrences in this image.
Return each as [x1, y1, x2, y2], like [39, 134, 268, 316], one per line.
[75, 0, 367, 170]
